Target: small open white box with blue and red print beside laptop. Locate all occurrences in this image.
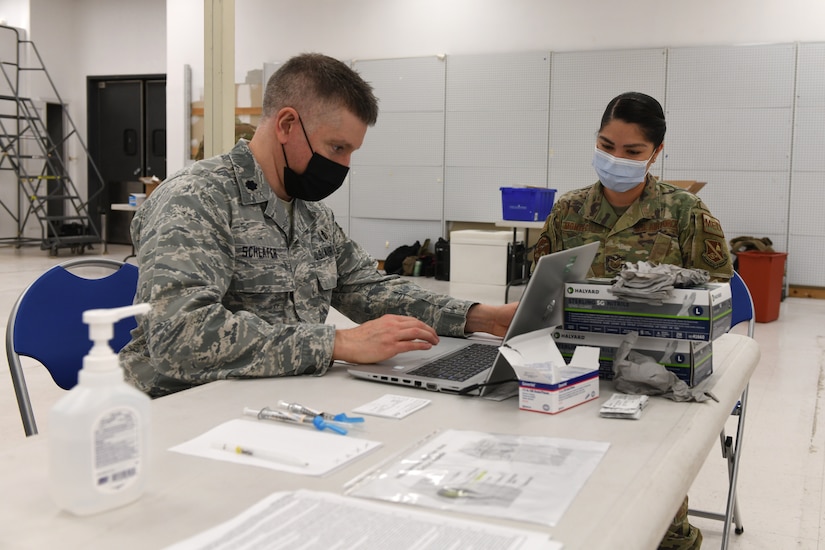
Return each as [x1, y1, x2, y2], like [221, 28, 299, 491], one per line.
[499, 328, 599, 414]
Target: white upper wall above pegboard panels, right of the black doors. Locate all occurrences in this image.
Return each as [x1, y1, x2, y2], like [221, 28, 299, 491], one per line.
[167, 0, 825, 173]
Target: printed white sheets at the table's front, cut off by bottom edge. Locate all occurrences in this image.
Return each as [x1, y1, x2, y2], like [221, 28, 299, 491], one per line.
[161, 490, 562, 550]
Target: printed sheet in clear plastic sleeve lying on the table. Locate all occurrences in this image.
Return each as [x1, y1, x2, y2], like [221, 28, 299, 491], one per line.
[348, 430, 610, 526]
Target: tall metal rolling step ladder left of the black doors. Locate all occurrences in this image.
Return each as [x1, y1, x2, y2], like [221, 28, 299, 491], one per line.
[0, 25, 105, 256]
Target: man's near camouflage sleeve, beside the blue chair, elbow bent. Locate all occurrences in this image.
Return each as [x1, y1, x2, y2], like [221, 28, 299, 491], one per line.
[121, 176, 335, 396]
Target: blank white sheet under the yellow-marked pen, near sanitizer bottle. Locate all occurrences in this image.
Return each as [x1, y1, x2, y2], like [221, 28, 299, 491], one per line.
[169, 419, 381, 476]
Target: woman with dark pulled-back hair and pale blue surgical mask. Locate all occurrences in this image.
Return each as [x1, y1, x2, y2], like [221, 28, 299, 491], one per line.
[535, 92, 732, 550]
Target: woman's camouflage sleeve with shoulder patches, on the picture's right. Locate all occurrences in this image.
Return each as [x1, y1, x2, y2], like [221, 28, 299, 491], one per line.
[682, 200, 733, 281]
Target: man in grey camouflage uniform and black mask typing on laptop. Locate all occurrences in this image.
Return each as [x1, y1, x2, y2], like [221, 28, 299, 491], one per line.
[120, 54, 515, 397]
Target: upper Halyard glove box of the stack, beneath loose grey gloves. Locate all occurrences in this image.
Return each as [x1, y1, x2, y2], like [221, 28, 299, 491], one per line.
[562, 282, 732, 342]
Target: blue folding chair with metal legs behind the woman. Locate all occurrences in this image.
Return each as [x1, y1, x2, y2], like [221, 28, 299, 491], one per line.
[688, 271, 756, 550]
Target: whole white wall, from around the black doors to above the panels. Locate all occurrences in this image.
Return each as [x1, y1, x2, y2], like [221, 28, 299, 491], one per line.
[6, 0, 825, 190]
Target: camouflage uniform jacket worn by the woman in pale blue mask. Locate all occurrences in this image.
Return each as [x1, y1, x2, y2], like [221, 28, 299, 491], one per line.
[535, 174, 733, 281]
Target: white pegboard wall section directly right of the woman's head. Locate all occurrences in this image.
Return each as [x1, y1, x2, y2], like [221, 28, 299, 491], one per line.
[664, 44, 796, 274]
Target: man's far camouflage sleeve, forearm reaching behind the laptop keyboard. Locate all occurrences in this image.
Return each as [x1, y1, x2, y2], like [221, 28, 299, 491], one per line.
[332, 223, 474, 336]
